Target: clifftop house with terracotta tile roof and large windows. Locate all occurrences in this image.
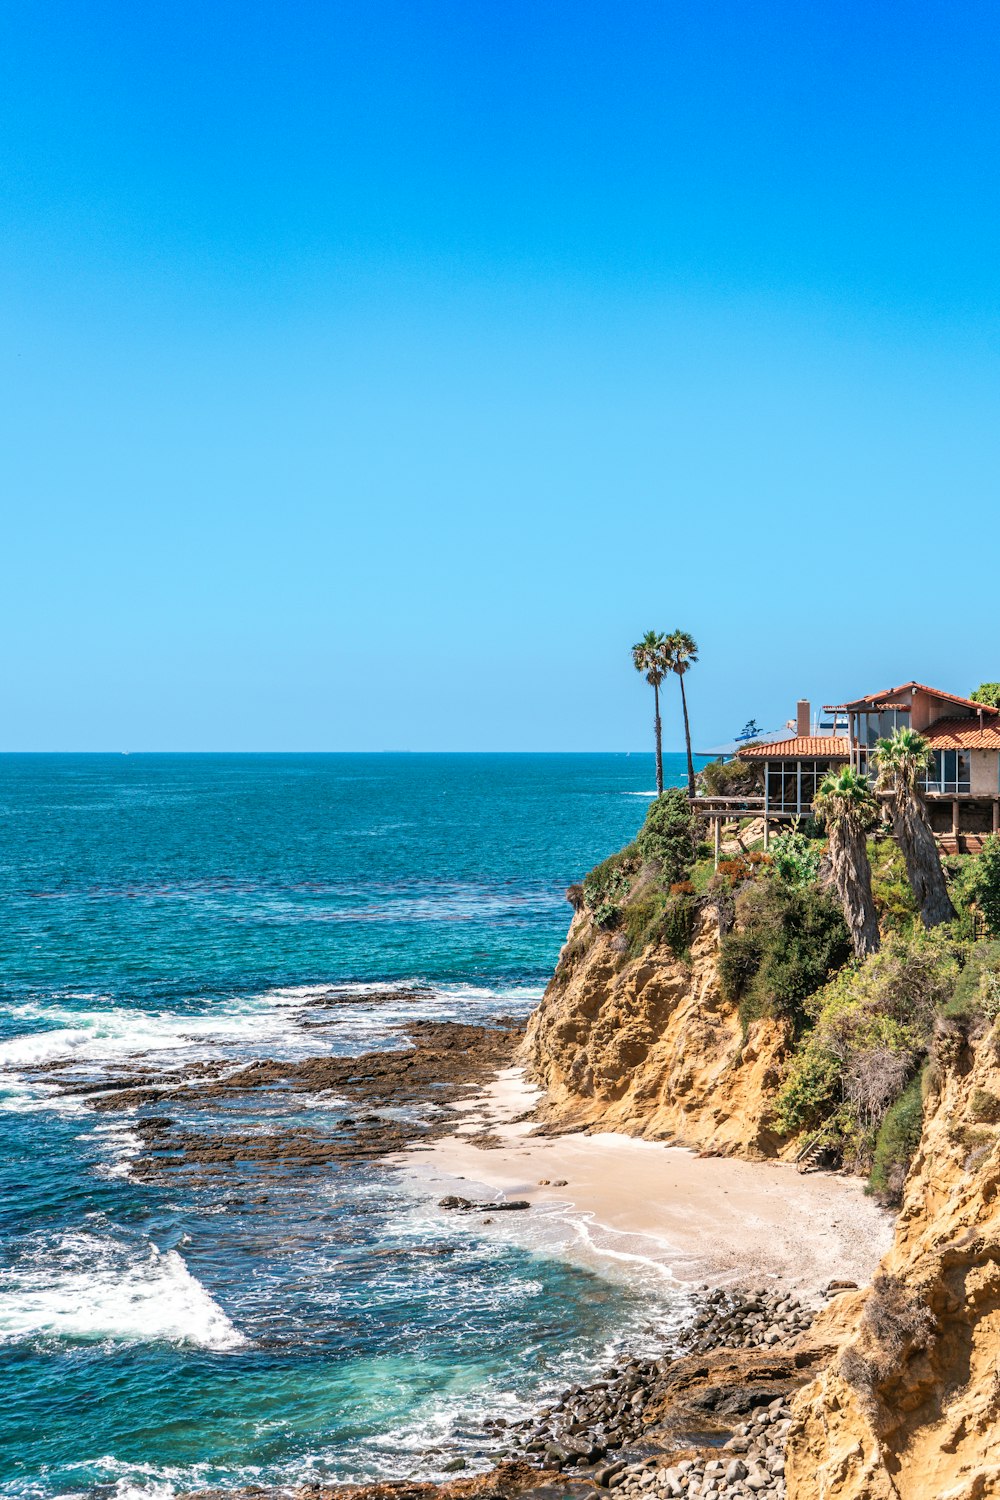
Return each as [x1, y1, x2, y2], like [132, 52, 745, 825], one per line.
[738, 683, 1000, 851]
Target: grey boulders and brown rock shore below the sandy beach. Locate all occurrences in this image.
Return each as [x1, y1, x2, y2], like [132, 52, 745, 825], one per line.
[181, 1283, 847, 1500]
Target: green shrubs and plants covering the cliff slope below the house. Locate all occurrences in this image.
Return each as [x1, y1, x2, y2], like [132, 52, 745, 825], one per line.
[562, 774, 1000, 1202]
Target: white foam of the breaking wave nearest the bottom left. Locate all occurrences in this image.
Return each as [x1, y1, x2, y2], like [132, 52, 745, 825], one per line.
[0, 1233, 246, 1350]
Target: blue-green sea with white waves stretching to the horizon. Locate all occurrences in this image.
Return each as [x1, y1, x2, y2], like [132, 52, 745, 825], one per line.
[0, 755, 695, 1497]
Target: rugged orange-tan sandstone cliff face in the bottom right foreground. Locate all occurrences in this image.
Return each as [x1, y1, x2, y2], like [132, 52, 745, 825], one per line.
[787, 1023, 1000, 1500]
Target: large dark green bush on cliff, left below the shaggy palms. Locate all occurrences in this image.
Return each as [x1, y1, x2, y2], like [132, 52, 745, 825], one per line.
[720, 881, 852, 1026]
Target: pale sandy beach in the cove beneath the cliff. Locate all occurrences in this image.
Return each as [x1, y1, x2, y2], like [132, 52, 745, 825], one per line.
[394, 1068, 892, 1299]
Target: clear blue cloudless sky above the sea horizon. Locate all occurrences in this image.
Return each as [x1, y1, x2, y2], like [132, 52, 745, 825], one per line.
[0, 0, 1000, 750]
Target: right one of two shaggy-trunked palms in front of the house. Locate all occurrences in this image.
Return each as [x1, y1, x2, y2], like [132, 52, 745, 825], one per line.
[876, 729, 955, 927]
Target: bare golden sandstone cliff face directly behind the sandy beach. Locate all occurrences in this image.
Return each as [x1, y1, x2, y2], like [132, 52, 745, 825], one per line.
[522, 912, 787, 1157]
